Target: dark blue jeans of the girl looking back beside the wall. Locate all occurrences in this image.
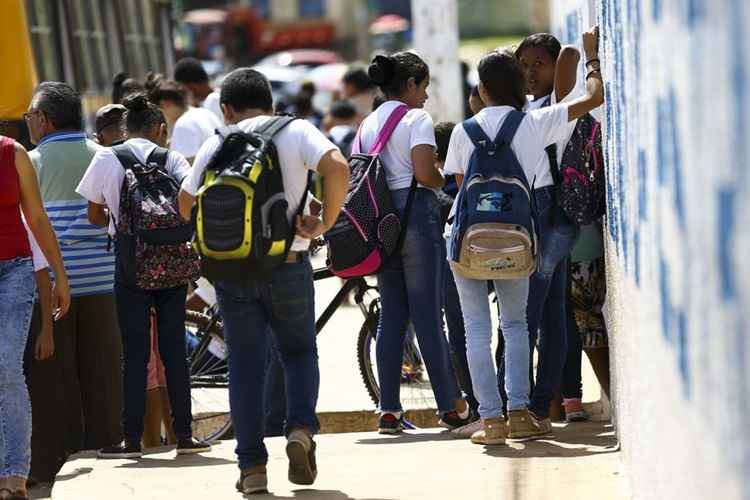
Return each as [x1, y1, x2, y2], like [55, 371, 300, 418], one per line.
[527, 186, 579, 418]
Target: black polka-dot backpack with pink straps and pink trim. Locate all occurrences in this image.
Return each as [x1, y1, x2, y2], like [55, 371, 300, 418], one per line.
[325, 105, 415, 278]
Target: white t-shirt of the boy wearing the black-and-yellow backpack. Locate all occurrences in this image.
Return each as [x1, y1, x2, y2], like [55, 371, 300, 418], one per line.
[182, 116, 338, 252]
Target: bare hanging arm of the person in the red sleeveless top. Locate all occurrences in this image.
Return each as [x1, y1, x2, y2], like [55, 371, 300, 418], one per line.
[16, 144, 70, 317]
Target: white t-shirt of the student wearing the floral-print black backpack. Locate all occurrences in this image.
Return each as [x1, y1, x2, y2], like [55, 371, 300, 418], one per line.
[76, 139, 190, 236]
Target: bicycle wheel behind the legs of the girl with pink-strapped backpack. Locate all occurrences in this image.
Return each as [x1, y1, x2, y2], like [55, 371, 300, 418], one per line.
[357, 299, 437, 410]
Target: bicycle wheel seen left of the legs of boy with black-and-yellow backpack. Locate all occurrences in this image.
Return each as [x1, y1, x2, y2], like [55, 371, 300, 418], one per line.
[185, 311, 232, 442]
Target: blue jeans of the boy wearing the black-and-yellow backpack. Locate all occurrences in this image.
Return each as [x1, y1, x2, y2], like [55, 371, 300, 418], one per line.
[216, 256, 320, 469]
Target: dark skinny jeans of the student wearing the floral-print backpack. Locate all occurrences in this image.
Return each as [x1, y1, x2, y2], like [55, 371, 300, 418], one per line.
[115, 271, 193, 443]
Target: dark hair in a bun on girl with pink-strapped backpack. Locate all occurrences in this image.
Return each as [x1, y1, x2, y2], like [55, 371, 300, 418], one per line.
[367, 52, 430, 97]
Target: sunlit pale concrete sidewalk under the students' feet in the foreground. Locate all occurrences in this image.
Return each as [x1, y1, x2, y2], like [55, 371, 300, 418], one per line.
[52, 422, 629, 500]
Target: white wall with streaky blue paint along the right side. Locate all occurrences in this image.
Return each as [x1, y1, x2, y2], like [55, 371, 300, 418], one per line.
[551, 0, 750, 498]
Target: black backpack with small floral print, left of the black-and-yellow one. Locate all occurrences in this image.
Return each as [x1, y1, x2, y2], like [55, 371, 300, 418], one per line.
[112, 144, 199, 290]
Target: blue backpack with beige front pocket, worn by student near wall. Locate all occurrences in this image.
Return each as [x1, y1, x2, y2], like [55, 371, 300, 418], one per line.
[448, 110, 537, 280]
